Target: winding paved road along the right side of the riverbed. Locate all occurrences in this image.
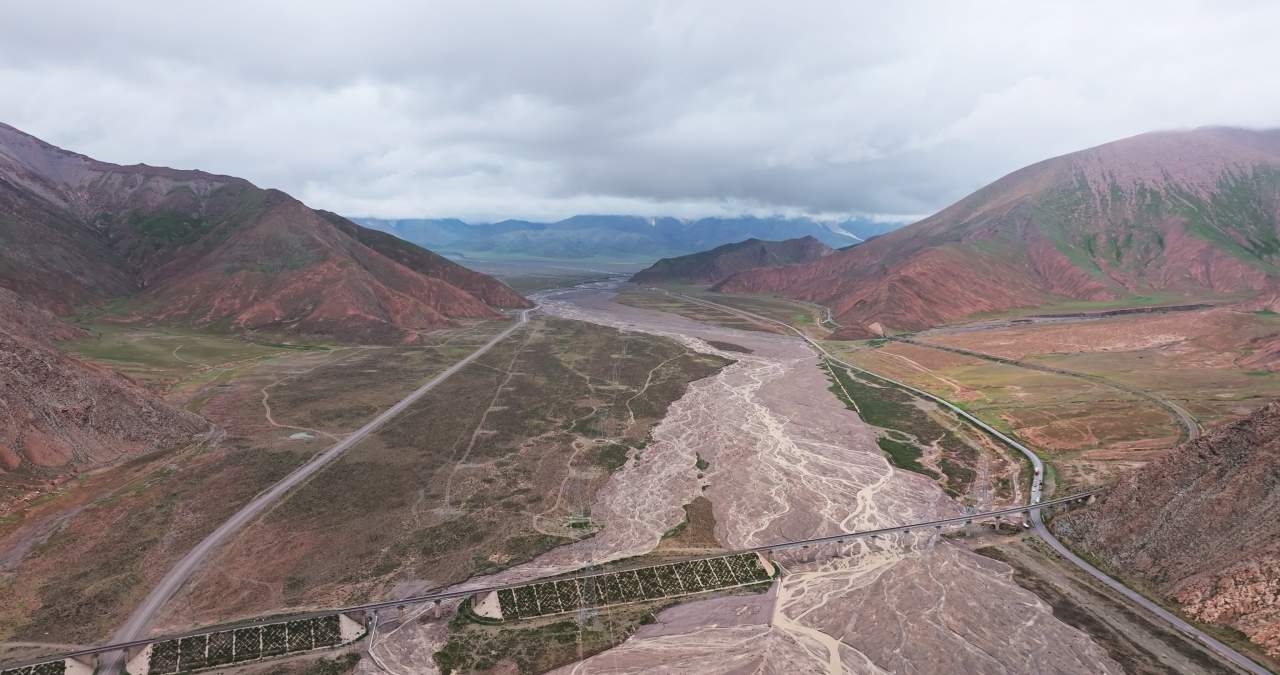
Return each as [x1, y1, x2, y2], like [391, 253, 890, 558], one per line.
[662, 291, 1271, 675]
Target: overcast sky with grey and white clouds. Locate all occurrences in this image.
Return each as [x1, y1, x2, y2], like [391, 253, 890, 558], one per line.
[0, 0, 1280, 220]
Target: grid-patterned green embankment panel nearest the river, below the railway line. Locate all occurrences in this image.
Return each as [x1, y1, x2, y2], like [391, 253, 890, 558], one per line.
[498, 553, 769, 620]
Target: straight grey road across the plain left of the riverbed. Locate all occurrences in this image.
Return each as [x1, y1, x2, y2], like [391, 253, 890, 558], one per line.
[97, 307, 538, 675]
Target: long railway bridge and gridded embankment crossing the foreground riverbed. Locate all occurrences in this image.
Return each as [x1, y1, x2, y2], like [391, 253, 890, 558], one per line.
[0, 491, 1101, 675]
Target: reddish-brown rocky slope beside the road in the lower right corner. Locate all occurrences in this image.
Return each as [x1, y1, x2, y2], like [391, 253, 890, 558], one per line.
[1053, 402, 1280, 657]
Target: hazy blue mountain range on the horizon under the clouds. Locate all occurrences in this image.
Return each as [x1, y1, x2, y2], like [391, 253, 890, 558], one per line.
[352, 215, 900, 263]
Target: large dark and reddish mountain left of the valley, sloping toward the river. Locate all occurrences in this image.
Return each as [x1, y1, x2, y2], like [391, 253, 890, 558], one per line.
[0, 124, 529, 343]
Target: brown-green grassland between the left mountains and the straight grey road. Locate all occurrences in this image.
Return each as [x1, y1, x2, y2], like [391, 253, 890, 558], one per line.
[0, 321, 519, 643]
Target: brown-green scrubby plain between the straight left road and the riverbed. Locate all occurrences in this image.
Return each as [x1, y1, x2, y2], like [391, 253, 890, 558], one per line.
[152, 319, 728, 635]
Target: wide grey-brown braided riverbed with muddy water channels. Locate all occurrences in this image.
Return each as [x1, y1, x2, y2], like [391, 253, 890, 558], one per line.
[361, 283, 1121, 674]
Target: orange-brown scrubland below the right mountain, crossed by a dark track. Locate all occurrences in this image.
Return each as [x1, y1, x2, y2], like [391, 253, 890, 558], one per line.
[829, 309, 1280, 489]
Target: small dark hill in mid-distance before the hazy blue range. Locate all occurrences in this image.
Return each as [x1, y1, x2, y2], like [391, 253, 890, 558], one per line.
[631, 237, 836, 284]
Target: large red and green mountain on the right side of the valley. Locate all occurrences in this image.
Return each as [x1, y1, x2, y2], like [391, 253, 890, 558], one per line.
[717, 128, 1280, 337]
